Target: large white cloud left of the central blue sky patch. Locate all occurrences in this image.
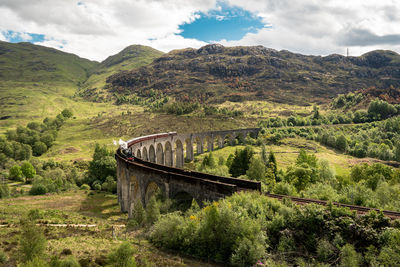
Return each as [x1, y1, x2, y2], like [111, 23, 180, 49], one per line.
[0, 0, 216, 60]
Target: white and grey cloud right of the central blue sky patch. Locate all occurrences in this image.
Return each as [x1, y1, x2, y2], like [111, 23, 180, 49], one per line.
[225, 0, 400, 55]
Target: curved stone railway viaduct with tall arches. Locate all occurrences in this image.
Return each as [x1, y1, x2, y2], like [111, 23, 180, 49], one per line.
[115, 128, 261, 217]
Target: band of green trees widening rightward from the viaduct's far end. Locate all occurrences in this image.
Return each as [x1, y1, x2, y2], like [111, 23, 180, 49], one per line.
[261, 117, 400, 161]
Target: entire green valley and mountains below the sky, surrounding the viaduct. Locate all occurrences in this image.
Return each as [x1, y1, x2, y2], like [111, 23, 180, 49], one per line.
[0, 42, 400, 267]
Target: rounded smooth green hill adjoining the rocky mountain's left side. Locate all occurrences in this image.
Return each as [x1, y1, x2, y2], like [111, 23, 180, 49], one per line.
[79, 45, 164, 101]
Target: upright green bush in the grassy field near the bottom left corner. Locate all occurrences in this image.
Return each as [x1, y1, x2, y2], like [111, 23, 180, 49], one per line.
[19, 220, 47, 262]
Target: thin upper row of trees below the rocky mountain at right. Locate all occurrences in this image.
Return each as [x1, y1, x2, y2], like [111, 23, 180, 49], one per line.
[259, 99, 400, 128]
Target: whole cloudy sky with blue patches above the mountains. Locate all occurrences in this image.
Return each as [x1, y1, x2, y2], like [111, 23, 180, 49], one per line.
[0, 0, 400, 61]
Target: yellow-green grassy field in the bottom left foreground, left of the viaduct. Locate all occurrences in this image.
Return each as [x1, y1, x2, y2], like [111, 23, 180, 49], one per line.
[0, 190, 216, 266]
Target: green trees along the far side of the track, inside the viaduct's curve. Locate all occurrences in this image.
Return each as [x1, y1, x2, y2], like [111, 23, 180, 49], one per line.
[198, 146, 400, 214]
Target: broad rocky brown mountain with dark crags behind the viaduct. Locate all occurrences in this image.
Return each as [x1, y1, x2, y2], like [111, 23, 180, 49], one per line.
[104, 44, 400, 104]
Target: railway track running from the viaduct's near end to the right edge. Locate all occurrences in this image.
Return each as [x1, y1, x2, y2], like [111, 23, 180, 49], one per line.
[264, 193, 400, 219]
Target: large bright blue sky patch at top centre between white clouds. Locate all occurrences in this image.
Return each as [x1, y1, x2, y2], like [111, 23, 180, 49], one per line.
[179, 2, 266, 42]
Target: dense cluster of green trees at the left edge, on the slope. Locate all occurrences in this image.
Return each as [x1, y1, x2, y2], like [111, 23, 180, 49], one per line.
[0, 109, 72, 161]
